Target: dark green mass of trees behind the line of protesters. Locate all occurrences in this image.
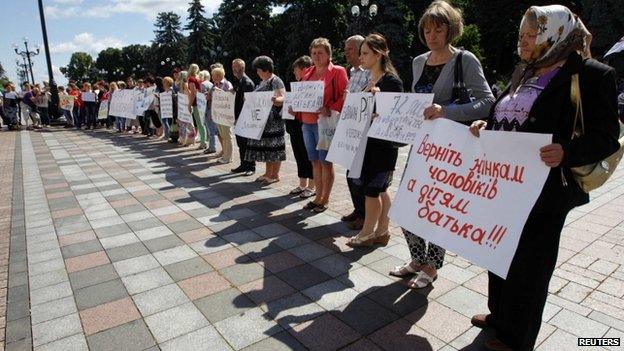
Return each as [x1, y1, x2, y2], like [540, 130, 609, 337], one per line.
[75, 0, 624, 87]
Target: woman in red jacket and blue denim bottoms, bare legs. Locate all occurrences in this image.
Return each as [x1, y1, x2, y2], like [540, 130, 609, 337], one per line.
[301, 38, 348, 213]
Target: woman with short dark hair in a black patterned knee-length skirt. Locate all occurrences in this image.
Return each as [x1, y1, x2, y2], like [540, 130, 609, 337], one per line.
[245, 56, 286, 185]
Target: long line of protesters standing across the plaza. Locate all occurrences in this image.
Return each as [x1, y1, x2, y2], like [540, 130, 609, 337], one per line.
[4, 1, 619, 350]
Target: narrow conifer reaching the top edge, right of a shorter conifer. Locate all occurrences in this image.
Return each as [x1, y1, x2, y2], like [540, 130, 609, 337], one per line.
[184, 0, 215, 67]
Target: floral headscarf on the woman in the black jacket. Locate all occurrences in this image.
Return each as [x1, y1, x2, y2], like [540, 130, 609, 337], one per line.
[511, 5, 591, 93]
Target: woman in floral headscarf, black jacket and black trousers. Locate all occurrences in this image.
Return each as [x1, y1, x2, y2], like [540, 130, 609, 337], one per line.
[471, 5, 619, 350]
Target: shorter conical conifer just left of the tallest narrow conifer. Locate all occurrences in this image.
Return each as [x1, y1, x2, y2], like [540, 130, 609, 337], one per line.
[152, 12, 187, 75]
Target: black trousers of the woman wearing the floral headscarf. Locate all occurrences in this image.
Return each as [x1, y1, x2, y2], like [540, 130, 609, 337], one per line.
[488, 212, 567, 350]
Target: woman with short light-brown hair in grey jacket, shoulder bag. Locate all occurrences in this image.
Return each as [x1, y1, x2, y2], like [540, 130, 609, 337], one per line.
[390, 1, 494, 289]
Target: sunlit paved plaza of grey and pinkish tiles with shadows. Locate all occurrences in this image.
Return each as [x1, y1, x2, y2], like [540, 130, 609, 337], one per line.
[0, 127, 624, 351]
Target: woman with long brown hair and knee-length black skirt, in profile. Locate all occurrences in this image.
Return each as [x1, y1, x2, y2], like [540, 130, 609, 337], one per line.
[347, 34, 403, 247]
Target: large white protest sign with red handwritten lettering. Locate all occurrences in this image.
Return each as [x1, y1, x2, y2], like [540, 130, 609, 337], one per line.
[390, 118, 552, 278]
